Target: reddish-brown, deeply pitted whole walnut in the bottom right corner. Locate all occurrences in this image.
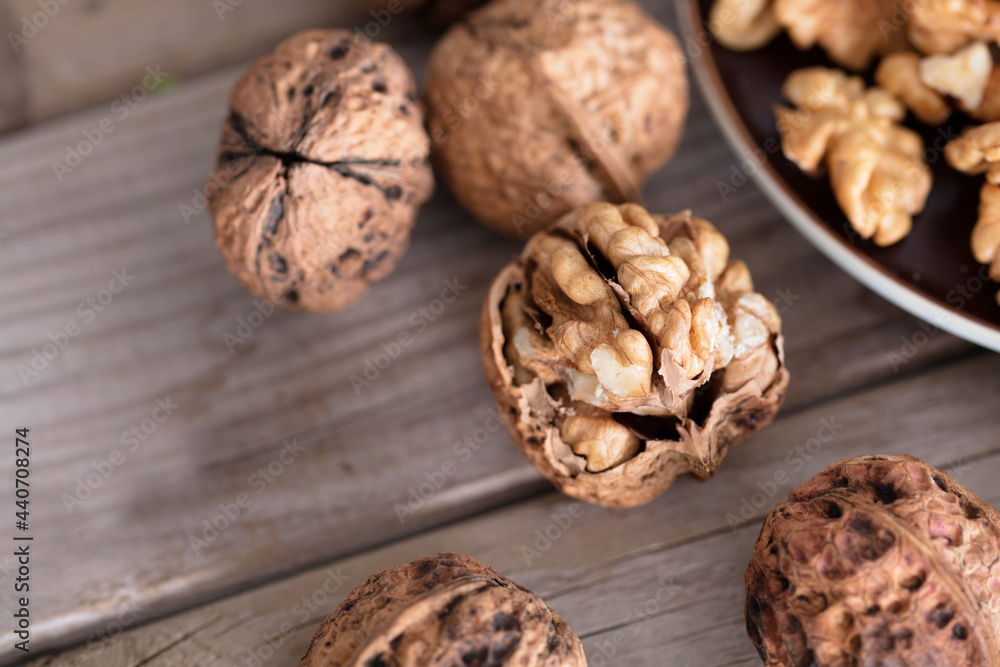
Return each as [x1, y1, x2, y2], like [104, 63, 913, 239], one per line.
[746, 456, 1000, 667]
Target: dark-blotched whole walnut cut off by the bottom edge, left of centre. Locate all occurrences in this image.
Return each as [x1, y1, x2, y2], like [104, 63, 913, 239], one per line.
[299, 553, 587, 667]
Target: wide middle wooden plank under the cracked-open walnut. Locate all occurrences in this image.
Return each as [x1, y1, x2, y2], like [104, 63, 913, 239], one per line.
[0, 0, 970, 647]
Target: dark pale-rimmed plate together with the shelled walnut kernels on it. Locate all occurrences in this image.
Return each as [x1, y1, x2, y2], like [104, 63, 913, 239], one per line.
[678, 0, 1000, 351]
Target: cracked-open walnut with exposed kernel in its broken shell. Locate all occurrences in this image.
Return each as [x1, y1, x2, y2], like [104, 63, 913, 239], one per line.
[480, 203, 788, 507]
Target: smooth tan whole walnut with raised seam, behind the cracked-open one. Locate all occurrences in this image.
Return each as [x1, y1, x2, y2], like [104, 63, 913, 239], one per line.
[427, 0, 688, 237]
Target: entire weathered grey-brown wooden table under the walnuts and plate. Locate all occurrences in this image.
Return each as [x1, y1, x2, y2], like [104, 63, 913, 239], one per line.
[0, 0, 1000, 667]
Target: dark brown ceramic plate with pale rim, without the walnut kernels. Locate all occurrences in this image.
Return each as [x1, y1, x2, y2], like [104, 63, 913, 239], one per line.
[677, 0, 1000, 351]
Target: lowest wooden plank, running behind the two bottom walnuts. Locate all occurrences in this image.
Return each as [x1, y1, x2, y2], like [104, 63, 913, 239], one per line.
[23, 357, 1000, 667]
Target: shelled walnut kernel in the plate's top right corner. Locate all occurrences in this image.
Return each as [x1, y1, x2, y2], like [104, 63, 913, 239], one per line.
[907, 0, 1000, 53]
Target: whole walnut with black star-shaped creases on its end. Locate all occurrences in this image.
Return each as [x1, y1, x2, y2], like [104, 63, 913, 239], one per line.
[206, 30, 433, 312]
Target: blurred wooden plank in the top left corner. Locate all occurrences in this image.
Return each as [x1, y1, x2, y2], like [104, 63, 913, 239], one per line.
[0, 0, 372, 131]
